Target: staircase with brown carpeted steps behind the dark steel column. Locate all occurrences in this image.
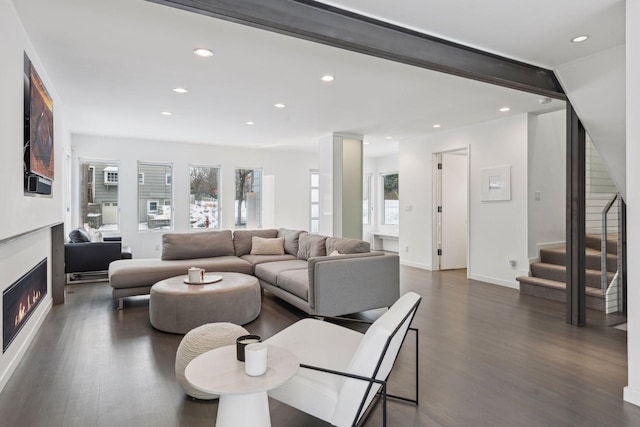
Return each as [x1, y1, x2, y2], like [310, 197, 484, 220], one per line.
[516, 233, 618, 311]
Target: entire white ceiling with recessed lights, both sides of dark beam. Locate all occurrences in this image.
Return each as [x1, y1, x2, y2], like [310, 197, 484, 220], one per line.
[13, 0, 624, 155]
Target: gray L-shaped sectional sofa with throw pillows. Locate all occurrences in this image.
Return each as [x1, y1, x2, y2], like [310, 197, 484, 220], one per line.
[109, 229, 400, 316]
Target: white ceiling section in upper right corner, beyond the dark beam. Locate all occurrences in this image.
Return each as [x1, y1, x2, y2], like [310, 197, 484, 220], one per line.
[320, 0, 633, 69]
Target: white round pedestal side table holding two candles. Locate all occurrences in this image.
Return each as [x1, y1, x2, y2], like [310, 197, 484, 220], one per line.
[185, 345, 300, 427]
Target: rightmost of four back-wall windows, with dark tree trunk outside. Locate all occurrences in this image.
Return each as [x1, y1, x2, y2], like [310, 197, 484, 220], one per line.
[235, 169, 262, 228]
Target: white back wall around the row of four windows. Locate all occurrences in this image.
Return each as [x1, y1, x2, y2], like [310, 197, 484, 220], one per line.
[72, 135, 318, 258]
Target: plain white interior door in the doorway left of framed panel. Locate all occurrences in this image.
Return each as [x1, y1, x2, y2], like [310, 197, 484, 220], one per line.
[440, 151, 467, 270]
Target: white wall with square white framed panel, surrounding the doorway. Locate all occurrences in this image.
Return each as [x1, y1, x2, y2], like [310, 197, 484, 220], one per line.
[399, 114, 528, 287]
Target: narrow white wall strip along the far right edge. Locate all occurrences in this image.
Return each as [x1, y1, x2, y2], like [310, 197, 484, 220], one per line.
[624, 1, 640, 405]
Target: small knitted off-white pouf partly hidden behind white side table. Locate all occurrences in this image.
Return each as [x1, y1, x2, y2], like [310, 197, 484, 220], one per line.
[176, 323, 249, 400]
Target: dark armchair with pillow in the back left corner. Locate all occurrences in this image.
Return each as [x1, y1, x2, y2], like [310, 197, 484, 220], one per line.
[64, 228, 132, 283]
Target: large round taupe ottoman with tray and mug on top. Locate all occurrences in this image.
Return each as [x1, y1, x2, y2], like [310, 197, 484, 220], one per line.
[149, 273, 261, 334]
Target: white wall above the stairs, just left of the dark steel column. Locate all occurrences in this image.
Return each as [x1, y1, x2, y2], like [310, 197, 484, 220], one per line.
[521, 110, 567, 260]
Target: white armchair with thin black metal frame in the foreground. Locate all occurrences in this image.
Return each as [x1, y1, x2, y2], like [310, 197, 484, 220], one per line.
[266, 292, 421, 426]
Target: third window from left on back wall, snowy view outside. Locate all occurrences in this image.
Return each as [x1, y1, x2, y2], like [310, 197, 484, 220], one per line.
[189, 165, 220, 228]
